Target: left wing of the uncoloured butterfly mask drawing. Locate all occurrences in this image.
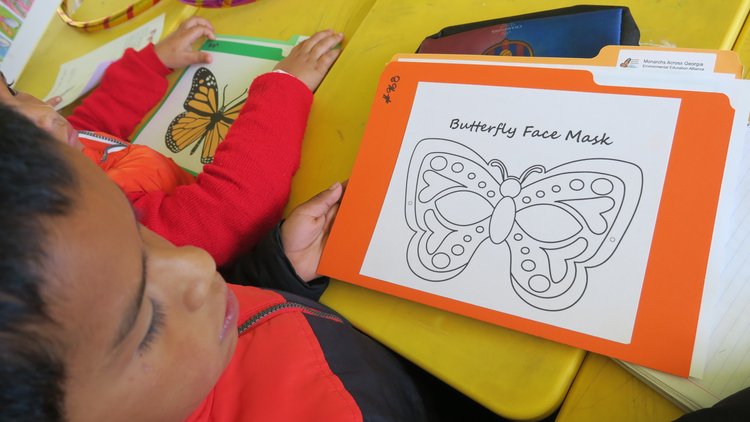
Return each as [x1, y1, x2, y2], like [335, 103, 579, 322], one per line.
[405, 138, 500, 281]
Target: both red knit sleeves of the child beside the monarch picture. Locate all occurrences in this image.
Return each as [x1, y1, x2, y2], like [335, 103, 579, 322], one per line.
[68, 45, 312, 266]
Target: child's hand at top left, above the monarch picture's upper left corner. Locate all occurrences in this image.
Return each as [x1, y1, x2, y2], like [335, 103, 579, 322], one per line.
[154, 16, 216, 69]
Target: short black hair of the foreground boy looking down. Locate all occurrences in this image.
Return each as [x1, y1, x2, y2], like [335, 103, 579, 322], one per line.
[0, 104, 77, 421]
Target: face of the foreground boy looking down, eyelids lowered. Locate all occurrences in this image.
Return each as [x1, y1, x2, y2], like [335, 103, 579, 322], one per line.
[49, 148, 238, 421]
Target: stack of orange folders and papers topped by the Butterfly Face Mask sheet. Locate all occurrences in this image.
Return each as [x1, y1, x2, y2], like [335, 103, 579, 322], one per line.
[319, 47, 750, 377]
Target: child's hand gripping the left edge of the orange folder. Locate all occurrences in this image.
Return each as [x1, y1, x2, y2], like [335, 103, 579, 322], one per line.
[281, 182, 344, 281]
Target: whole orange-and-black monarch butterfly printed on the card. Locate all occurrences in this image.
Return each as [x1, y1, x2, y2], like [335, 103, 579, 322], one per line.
[165, 67, 247, 164]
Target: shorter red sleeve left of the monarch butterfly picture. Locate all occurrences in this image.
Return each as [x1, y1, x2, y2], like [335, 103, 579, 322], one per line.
[68, 44, 171, 139]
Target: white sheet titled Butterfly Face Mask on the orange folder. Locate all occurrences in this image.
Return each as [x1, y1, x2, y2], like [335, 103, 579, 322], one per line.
[361, 83, 680, 343]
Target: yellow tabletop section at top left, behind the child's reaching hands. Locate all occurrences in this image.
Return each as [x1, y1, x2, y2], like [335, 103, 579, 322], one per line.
[15, 0, 374, 105]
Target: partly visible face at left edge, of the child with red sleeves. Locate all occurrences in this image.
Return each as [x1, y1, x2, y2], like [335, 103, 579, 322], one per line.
[0, 73, 81, 150]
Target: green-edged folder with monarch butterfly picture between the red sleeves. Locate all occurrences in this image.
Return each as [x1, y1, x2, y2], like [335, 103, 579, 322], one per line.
[133, 35, 306, 174]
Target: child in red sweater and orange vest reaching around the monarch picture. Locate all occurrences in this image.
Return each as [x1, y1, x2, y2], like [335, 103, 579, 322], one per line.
[0, 17, 343, 266]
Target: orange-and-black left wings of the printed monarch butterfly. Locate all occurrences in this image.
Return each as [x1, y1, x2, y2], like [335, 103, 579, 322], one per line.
[165, 67, 219, 155]
